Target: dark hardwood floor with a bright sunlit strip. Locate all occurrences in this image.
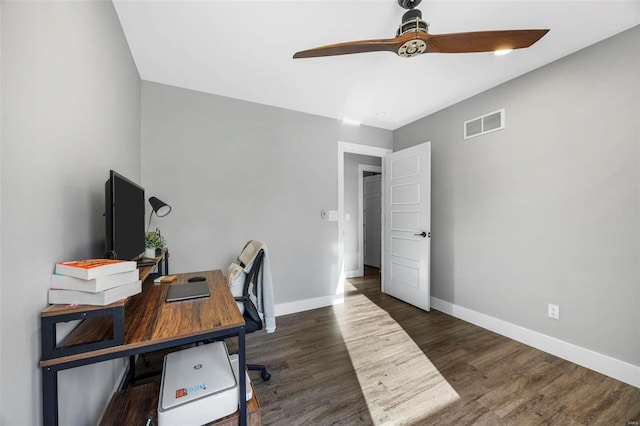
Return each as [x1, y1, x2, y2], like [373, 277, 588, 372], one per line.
[247, 268, 640, 426]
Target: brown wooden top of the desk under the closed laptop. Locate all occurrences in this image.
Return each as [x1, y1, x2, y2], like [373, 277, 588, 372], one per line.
[40, 270, 244, 367]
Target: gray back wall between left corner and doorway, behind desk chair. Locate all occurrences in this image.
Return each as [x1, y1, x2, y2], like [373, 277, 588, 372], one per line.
[142, 82, 392, 305]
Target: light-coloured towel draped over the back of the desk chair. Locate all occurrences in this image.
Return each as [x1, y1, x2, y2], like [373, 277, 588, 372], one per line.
[238, 240, 276, 333]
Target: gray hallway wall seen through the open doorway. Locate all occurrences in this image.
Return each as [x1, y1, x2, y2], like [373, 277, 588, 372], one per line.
[344, 152, 382, 272]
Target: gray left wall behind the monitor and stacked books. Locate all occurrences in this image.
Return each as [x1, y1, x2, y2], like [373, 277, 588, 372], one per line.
[0, 1, 141, 425]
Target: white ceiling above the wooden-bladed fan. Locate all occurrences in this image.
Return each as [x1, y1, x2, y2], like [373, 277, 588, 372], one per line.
[114, 0, 640, 130]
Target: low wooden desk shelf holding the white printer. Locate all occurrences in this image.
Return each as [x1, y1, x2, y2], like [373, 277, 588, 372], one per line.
[100, 382, 261, 426]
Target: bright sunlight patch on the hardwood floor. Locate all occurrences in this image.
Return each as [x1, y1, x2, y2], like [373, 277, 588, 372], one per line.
[334, 295, 460, 425]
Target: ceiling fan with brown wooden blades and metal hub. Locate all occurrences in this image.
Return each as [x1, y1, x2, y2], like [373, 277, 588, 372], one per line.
[293, 0, 549, 59]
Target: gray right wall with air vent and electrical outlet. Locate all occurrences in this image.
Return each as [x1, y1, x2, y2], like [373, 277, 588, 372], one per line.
[394, 27, 640, 365]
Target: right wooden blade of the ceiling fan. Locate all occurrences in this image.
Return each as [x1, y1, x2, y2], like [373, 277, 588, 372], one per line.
[427, 30, 549, 53]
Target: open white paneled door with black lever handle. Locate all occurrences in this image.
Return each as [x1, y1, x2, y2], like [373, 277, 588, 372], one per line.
[382, 142, 431, 311]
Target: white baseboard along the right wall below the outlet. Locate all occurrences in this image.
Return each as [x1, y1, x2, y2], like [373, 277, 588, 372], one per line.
[431, 297, 640, 388]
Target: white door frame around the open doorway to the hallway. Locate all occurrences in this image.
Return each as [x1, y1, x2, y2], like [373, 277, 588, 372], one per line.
[335, 141, 393, 297]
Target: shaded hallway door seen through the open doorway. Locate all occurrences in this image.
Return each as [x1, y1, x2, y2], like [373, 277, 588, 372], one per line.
[362, 175, 382, 268]
